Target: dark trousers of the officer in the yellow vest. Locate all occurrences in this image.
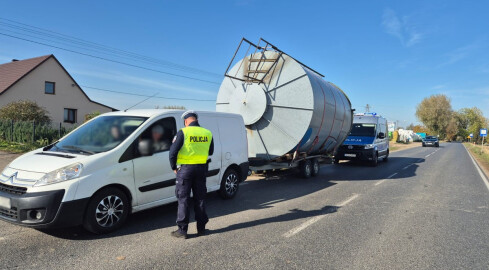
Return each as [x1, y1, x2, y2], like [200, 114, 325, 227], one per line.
[175, 164, 209, 234]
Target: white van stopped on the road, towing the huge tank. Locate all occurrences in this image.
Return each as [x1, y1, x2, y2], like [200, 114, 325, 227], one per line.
[0, 110, 248, 233]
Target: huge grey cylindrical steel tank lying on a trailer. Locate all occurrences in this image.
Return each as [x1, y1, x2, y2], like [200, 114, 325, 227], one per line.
[216, 51, 352, 160]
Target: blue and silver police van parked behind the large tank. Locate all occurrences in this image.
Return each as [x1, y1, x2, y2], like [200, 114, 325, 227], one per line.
[334, 113, 389, 166]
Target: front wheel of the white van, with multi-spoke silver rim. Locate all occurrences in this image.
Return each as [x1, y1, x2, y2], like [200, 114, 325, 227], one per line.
[83, 187, 130, 234]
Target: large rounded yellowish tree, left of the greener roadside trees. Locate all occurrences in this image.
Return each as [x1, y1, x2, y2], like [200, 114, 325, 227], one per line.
[416, 94, 452, 137]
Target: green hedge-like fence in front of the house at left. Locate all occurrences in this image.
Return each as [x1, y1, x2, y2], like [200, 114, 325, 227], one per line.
[0, 120, 75, 145]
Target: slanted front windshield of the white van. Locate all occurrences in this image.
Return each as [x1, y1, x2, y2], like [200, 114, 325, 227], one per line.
[48, 116, 147, 155]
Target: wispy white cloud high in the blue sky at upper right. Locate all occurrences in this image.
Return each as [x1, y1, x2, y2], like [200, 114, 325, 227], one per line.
[382, 8, 423, 47]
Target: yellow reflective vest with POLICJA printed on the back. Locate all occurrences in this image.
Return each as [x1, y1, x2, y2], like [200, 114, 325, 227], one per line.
[177, 126, 212, 165]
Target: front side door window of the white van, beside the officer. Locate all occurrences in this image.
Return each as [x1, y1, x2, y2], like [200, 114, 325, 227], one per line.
[139, 117, 177, 153]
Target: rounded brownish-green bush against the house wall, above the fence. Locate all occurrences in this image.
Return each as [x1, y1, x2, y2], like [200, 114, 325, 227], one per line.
[0, 100, 51, 123]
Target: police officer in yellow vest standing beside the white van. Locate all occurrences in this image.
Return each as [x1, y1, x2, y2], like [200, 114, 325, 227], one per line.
[170, 111, 214, 238]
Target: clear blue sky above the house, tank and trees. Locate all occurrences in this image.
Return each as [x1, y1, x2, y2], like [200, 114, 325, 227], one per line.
[0, 0, 489, 125]
